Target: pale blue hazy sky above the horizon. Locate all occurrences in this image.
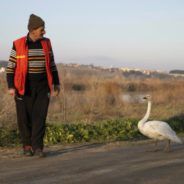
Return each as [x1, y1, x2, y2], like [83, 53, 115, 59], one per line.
[0, 0, 184, 71]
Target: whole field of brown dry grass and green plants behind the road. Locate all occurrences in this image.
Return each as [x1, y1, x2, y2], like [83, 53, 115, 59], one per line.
[0, 65, 184, 146]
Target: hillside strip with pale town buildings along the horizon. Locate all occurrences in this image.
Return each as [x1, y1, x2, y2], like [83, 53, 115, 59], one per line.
[0, 61, 184, 79]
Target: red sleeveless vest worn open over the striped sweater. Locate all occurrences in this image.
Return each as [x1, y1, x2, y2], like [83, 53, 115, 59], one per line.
[14, 36, 53, 95]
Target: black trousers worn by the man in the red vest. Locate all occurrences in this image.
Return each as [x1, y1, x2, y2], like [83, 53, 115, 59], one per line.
[15, 79, 50, 150]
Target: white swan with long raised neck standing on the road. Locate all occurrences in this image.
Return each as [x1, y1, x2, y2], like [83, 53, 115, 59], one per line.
[138, 95, 182, 151]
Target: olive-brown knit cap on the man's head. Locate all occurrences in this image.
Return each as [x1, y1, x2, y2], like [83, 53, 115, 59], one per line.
[27, 14, 45, 31]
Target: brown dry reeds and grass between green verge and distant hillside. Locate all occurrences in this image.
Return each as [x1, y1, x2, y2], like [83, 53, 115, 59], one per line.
[0, 66, 184, 129]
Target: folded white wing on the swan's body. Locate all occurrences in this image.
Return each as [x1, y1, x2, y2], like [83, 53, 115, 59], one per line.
[144, 121, 176, 138]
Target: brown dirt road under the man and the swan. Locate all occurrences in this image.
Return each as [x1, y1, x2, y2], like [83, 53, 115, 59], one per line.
[0, 141, 184, 184]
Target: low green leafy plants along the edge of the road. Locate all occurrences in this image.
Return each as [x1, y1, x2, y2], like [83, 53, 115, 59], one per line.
[0, 119, 184, 146]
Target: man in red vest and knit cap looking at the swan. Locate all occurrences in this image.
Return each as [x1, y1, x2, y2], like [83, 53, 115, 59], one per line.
[6, 14, 60, 157]
